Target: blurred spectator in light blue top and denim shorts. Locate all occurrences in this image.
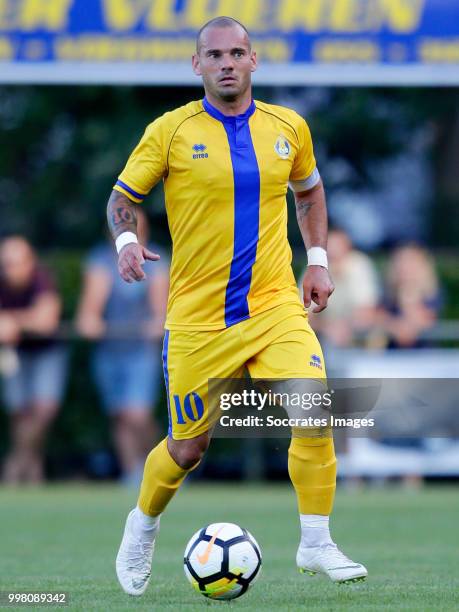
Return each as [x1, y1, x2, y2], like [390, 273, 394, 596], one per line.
[77, 207, 169, 484]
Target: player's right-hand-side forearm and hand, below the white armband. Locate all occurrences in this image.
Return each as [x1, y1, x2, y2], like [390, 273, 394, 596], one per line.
[295, 181, 334, 312]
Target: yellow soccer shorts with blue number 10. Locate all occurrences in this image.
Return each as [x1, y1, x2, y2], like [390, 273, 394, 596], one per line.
[163, 302, 326, 440]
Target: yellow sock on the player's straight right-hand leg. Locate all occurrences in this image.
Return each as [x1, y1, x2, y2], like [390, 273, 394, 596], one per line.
[288, 436, 336, 515]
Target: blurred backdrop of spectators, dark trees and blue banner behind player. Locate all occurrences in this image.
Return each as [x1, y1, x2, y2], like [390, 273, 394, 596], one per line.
[0, 0, 459, 486]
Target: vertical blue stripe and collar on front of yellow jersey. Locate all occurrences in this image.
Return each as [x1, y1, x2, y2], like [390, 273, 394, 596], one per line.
[203, 98, 260, 327]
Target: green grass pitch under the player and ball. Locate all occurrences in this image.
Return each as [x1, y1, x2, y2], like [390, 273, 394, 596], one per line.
[0, 483, 459, 612]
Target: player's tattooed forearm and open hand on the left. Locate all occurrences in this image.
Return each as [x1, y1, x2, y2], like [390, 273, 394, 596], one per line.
[107, 190, 160, 283]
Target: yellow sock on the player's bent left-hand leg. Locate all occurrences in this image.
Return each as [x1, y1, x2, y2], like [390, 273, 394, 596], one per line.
[137, 438, 199, 516]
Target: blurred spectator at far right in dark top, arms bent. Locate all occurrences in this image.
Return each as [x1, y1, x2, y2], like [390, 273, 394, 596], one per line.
[379, 244, 441, 348]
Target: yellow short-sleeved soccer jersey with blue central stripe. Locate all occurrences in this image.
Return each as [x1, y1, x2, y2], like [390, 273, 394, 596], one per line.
[114, 98, 320, 330]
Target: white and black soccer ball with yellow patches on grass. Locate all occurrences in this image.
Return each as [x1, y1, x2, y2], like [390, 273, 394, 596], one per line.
[184, 523, 261, 599]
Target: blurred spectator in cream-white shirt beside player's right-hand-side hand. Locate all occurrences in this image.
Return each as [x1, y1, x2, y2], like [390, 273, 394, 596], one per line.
[309, 229, 379, 347]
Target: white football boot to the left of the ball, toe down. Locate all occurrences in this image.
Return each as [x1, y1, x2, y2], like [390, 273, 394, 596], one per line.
[116, 509, 159, 596]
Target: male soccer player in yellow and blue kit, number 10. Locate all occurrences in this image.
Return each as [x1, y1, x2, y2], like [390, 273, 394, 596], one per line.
[108, 17, 367, 595]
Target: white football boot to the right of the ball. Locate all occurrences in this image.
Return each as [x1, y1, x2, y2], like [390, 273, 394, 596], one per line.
[296, 543, 368, 584]
